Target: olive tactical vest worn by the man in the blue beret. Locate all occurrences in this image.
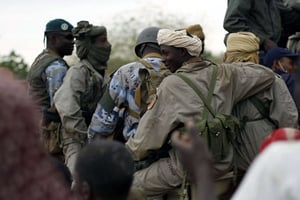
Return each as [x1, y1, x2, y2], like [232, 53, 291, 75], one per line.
[27, 50, 68, 108]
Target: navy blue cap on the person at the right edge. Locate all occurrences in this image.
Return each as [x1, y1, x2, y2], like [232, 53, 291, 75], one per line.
[264, 47, 300, 67]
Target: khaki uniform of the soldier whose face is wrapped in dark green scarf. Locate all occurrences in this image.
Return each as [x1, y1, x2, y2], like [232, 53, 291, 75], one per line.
[54, 60, 104, 172]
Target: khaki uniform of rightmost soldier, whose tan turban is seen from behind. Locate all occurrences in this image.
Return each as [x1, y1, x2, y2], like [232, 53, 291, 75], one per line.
[233, 76, 298, 170]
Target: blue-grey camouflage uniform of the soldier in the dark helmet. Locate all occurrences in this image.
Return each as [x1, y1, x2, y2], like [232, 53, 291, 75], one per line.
[88, 53, 170, 140]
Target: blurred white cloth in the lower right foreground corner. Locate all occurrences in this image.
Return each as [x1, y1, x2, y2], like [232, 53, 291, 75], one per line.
[232, 141, 300, 200]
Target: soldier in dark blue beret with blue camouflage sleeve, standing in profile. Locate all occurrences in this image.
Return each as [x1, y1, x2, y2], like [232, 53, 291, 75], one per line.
[27, 19, 74, 155]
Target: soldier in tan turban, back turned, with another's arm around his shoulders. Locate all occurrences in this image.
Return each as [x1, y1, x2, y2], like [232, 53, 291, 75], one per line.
[224, 32, 298, 193]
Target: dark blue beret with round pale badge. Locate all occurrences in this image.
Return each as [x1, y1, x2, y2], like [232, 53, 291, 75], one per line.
[45, 19, 73, 33]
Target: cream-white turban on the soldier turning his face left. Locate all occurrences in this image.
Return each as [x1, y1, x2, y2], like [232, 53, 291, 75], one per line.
[157, 29, 202, 56]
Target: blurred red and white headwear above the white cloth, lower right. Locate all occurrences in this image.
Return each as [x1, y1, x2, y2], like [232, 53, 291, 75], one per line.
[259, 128, 300, 152]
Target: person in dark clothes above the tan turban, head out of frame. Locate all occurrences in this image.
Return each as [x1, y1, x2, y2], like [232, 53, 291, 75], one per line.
[223, 0, 282, 63]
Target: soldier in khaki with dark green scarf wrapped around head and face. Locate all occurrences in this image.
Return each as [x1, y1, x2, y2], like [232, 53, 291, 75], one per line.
[54, 21, 111, 173]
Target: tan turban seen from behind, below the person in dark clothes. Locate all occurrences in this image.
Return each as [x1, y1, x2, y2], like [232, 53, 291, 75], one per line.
[224, 32, 259, 63]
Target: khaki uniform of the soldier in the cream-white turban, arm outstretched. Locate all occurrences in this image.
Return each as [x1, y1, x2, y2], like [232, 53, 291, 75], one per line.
[126, 59, 275, 196]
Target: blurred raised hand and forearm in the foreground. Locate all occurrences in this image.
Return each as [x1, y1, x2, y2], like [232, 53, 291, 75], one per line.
[171, 121, 216, 200]
